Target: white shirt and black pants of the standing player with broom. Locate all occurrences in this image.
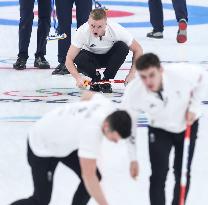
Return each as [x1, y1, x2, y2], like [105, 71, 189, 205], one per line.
[123, 65, 204, 205]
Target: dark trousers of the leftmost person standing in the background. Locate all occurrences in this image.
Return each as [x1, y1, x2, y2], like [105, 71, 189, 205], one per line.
[18, 0, 51, 58]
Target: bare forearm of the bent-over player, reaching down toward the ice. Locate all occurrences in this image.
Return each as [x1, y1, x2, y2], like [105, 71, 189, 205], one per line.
[80, 157, 108, 205]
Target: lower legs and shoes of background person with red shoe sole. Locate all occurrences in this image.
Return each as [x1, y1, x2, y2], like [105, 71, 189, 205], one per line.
[147, 0, 188, 43]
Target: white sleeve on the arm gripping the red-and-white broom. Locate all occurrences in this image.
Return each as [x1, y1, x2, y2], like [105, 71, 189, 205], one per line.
[189, 69, 208, 114]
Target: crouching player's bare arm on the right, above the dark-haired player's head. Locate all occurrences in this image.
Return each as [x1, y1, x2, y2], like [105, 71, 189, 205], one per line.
[125, 39, 143, 83]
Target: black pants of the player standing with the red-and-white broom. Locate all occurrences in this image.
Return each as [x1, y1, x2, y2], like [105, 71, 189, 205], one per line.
[149, 121, 198, 205]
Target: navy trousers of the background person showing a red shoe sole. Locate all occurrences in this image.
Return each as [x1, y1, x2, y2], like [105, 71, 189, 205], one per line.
[148, 0, 188, 32]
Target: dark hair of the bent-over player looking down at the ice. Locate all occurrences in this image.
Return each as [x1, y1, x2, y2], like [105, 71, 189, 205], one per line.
[106, 110, 132, 139]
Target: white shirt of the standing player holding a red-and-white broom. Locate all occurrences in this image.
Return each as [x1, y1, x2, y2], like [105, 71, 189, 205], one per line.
[122, 64, 205, 133]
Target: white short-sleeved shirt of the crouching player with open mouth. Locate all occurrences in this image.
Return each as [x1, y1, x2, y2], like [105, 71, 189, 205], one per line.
[72, 20, 133, 54]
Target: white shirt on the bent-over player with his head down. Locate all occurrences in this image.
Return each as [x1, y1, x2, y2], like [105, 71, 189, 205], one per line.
[29, 94, 116, 159]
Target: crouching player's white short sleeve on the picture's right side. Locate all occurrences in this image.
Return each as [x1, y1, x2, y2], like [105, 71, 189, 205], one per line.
[115, 24, 134, 47]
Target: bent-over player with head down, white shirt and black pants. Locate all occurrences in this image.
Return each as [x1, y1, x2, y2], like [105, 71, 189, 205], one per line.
[12, 93, 137, 205]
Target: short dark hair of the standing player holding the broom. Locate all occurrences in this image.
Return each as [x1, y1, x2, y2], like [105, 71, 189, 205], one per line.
[136, 53, 161, 71]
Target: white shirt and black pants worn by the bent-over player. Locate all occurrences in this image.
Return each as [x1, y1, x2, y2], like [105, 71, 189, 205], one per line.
[12, 94, 136, 205]
